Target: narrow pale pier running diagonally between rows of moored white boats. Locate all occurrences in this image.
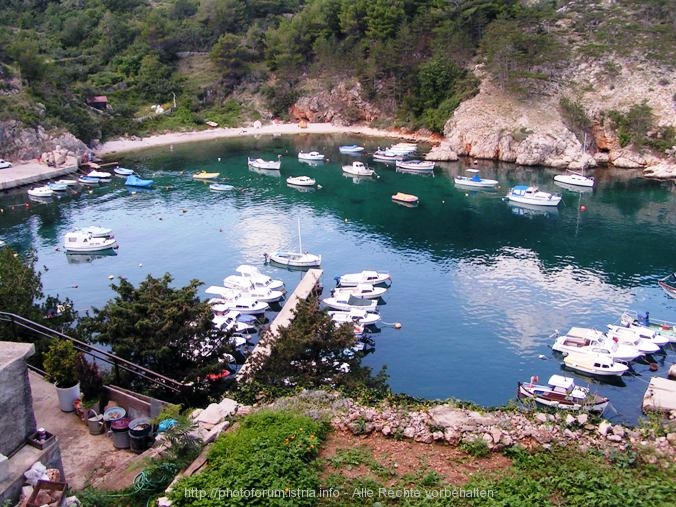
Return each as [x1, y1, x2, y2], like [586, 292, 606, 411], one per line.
[235, 269, 323, 382]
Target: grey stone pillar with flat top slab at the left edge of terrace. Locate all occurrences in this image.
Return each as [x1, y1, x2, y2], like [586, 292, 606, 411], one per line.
[0, 342, 36, 455]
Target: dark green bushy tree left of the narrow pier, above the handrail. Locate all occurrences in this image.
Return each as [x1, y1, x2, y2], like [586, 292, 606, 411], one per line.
[81, 274, 232, 381]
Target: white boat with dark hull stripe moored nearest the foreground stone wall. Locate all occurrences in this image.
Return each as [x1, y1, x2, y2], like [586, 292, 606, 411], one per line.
[517, 375, 608, 413]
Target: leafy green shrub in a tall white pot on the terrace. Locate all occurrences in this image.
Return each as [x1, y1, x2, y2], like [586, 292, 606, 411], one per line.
[43, 338, 81, 412]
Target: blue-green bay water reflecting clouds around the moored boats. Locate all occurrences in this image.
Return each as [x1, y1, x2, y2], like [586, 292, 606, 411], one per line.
[0, 135, 676, 423]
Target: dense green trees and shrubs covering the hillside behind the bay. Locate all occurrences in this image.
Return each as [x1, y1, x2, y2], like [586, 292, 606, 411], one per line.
[0, 0, 676, 142]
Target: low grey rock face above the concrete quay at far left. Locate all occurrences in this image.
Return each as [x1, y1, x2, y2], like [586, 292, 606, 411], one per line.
[0, 120, 87, 160]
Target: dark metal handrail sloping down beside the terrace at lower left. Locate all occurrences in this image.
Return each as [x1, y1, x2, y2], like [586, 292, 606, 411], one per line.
[0, 312, 189, 392]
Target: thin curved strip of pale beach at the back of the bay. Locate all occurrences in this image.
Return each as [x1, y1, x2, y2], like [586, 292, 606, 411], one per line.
[94, 123, 440, 157]
